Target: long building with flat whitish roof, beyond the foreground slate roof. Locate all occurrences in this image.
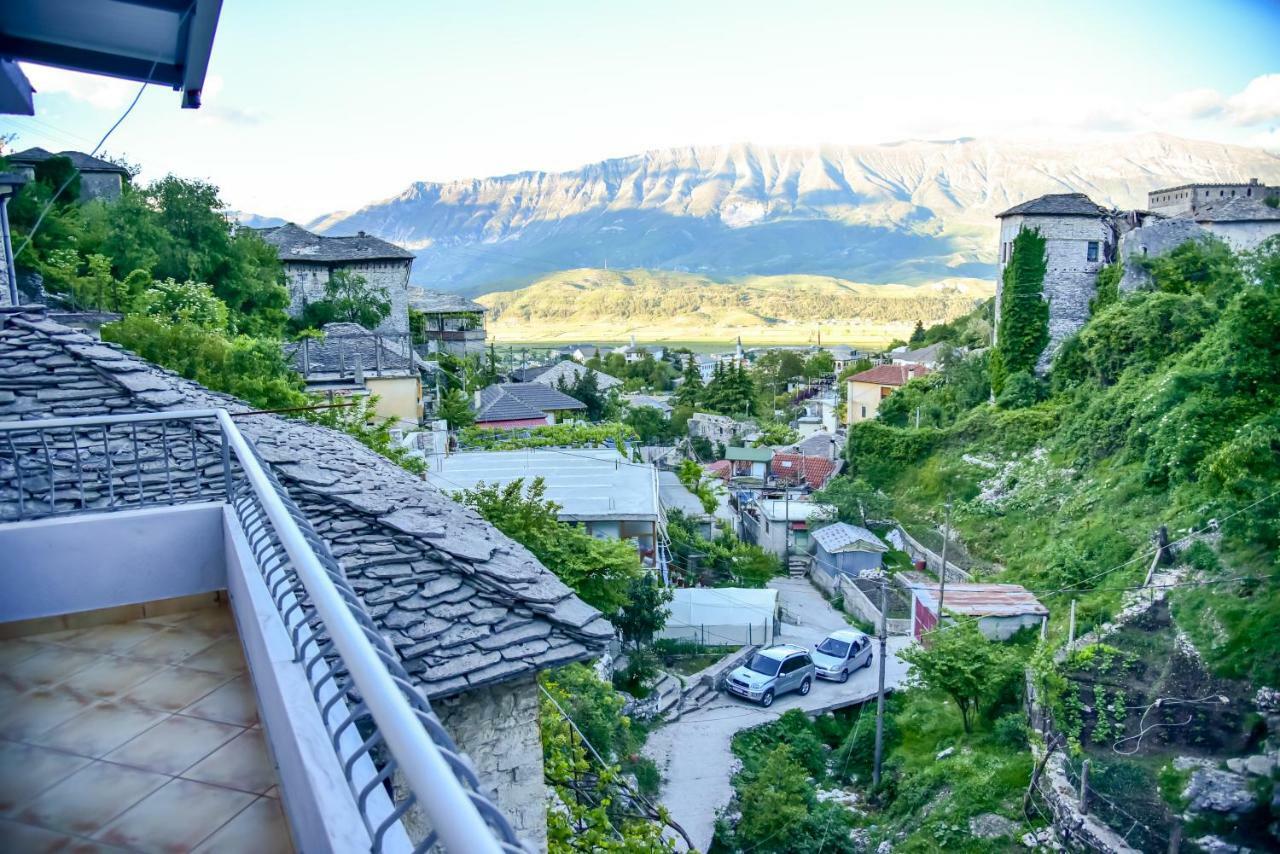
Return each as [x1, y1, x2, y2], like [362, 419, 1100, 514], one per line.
[426, 448, 660, 565]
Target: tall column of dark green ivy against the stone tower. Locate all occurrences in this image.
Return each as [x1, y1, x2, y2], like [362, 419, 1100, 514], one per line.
[991, 228, 1048, 394]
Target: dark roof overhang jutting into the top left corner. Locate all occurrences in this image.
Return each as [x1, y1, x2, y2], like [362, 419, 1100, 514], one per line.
[0, 0, 223, 115]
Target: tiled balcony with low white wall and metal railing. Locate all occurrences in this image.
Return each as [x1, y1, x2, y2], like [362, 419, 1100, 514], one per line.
[0, 408, 524, 851]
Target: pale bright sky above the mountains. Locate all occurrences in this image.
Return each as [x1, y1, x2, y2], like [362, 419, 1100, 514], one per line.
[0, 0, 1280, 223]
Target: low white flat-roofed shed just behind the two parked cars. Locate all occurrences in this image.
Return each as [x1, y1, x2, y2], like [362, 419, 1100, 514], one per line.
[658, 588, 778, 647]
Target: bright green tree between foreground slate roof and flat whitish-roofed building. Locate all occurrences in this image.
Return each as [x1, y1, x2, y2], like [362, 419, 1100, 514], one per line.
[453, 478, 644, 616]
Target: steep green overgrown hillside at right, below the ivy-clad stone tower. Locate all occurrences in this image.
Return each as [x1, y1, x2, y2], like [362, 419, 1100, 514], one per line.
[757, 238, 1280, 851]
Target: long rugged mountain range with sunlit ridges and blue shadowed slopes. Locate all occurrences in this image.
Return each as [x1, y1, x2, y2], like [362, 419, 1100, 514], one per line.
[307, 133, 1280, 294]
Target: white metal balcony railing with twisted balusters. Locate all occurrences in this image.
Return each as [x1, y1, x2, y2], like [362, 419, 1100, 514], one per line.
[0, 410, 526, 851]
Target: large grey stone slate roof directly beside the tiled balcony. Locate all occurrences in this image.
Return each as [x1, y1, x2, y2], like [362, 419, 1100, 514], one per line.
[0, 309, 613, 698]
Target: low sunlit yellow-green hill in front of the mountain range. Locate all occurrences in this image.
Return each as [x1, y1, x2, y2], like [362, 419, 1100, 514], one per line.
[480, 269, 995, 346]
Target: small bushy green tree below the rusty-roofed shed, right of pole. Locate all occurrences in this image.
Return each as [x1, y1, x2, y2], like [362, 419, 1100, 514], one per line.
[899, 620, 1016, 732]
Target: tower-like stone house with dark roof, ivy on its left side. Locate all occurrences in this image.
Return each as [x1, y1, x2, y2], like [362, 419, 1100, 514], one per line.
[996, 193, 1116, 371]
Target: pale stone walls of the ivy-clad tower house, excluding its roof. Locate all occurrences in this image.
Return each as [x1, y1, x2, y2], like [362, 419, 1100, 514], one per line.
[996, 216, 1112, 373]
